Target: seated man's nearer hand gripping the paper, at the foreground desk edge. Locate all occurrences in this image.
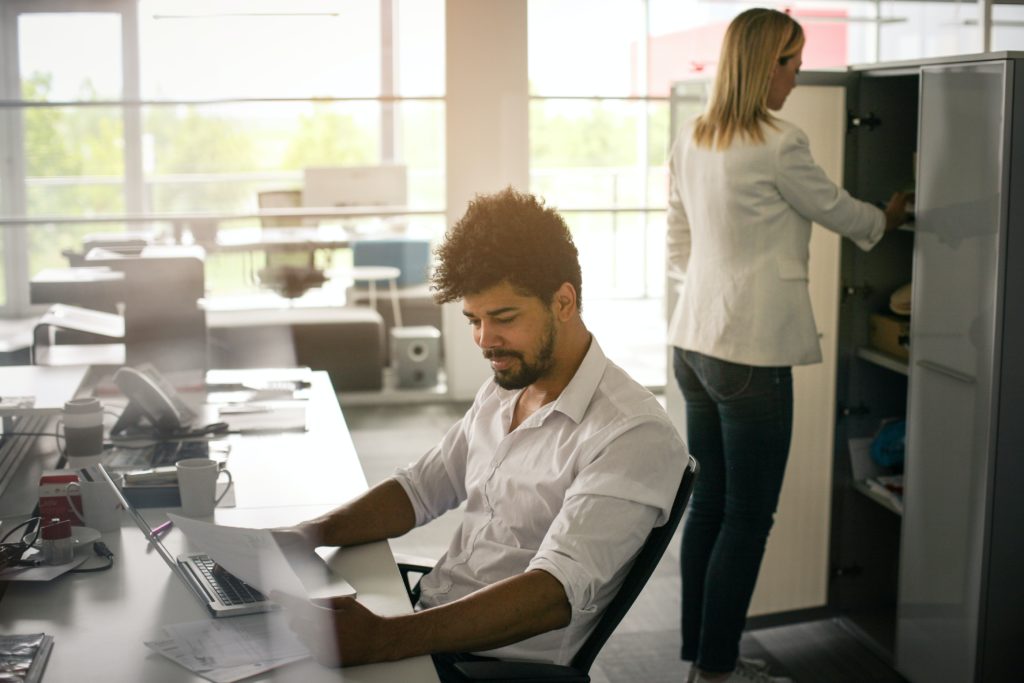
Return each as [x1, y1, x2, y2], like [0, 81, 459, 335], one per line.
[270, 591, 392, 667]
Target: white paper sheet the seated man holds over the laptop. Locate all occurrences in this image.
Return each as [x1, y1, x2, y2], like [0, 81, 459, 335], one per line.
[167, 513, 355, 598]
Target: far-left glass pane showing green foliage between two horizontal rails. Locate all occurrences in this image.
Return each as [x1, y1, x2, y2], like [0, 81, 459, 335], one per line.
[22, 106, 124, 216]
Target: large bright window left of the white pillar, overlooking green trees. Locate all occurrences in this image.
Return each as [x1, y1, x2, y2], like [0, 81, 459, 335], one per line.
[0, 0, 444, 314]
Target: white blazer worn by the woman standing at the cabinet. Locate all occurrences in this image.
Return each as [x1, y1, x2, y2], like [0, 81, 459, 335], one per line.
[668, 120, 886, 366]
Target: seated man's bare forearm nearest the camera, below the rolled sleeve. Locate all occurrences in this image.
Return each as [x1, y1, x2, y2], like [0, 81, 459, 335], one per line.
[382, 569, 572, 659]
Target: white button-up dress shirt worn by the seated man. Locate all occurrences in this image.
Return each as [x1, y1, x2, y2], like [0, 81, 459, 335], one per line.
[395, 339, 687, 664]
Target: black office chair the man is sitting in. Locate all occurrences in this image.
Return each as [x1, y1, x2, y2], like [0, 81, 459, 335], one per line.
[398, 456, 699, 683]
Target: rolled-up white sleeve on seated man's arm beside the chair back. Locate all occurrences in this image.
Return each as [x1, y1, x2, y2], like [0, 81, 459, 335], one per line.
[527, 422, 686, 612]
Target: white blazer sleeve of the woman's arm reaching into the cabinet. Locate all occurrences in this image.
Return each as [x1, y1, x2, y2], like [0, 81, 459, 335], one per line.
[776, 128, 886, 251]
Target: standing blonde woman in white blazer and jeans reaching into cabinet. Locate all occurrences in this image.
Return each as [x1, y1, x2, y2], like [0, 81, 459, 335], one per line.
[668, 9, 908, 683]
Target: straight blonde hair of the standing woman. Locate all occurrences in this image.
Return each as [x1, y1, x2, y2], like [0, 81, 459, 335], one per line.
[693, 8, 804, 150]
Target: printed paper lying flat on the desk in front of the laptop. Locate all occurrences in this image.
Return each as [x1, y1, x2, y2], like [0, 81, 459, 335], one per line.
[145, 612, 309, 683]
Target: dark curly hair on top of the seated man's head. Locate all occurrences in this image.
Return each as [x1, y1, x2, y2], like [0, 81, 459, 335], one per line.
[430, 187, 583, 309]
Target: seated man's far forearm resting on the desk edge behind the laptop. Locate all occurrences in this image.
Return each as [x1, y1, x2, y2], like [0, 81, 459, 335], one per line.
[299, 479, 416, 546]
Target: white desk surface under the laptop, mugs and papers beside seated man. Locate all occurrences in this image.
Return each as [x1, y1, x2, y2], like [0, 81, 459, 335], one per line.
[0, 371, 437, 683]
